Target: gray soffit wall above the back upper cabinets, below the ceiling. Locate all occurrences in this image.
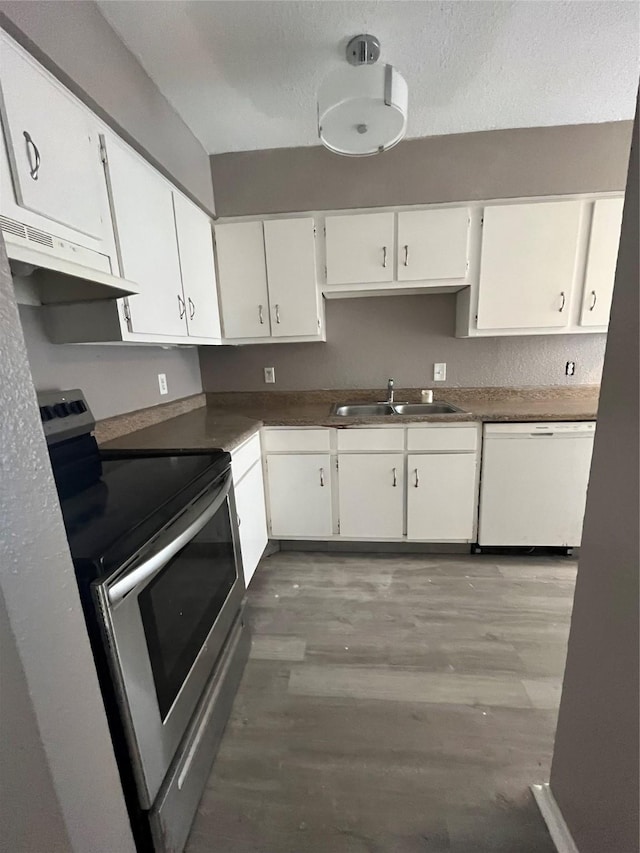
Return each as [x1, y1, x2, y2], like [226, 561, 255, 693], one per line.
[211, 121, 632, 216]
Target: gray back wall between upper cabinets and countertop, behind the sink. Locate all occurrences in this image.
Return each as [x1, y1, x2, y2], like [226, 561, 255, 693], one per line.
[200, 294, 606, 391]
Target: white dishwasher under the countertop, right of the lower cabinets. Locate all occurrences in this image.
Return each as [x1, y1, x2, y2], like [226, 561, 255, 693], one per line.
[478, 421, 596, 548]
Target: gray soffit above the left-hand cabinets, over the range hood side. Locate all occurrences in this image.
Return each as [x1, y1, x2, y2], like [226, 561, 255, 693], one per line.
[0, 0, 214, 211]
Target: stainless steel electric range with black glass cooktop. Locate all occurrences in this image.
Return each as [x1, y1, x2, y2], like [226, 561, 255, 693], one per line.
[38, 390, 250, 853]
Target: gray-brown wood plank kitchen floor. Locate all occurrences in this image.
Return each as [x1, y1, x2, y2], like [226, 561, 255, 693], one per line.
[187, 551, 575, 853]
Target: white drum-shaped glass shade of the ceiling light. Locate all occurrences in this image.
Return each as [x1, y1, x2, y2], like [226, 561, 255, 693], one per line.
[318, 65, 409, 157]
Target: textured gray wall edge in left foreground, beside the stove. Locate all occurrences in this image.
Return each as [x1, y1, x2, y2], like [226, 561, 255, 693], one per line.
[0, 237, 133, 853]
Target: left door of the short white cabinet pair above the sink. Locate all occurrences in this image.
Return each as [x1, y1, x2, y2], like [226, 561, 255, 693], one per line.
[325, 213, 395, 284]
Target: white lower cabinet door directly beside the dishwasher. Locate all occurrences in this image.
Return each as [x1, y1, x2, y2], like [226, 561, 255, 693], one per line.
[407, 453, 477, 542]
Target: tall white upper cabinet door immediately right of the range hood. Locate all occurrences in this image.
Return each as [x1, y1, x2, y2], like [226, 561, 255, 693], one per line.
[106, 136, 187, 335]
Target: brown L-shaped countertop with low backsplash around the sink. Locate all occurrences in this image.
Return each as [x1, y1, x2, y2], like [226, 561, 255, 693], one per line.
[96, 385, 599, 450]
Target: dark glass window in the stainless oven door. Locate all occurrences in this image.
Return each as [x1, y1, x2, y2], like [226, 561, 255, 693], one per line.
[138, 492, 237, 720]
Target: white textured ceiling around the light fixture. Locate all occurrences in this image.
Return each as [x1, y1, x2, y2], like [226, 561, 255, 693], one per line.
[98, 0, 640, 153]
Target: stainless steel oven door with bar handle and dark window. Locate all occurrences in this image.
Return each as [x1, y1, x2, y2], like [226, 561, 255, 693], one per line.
[95, 471, 244, 809]
